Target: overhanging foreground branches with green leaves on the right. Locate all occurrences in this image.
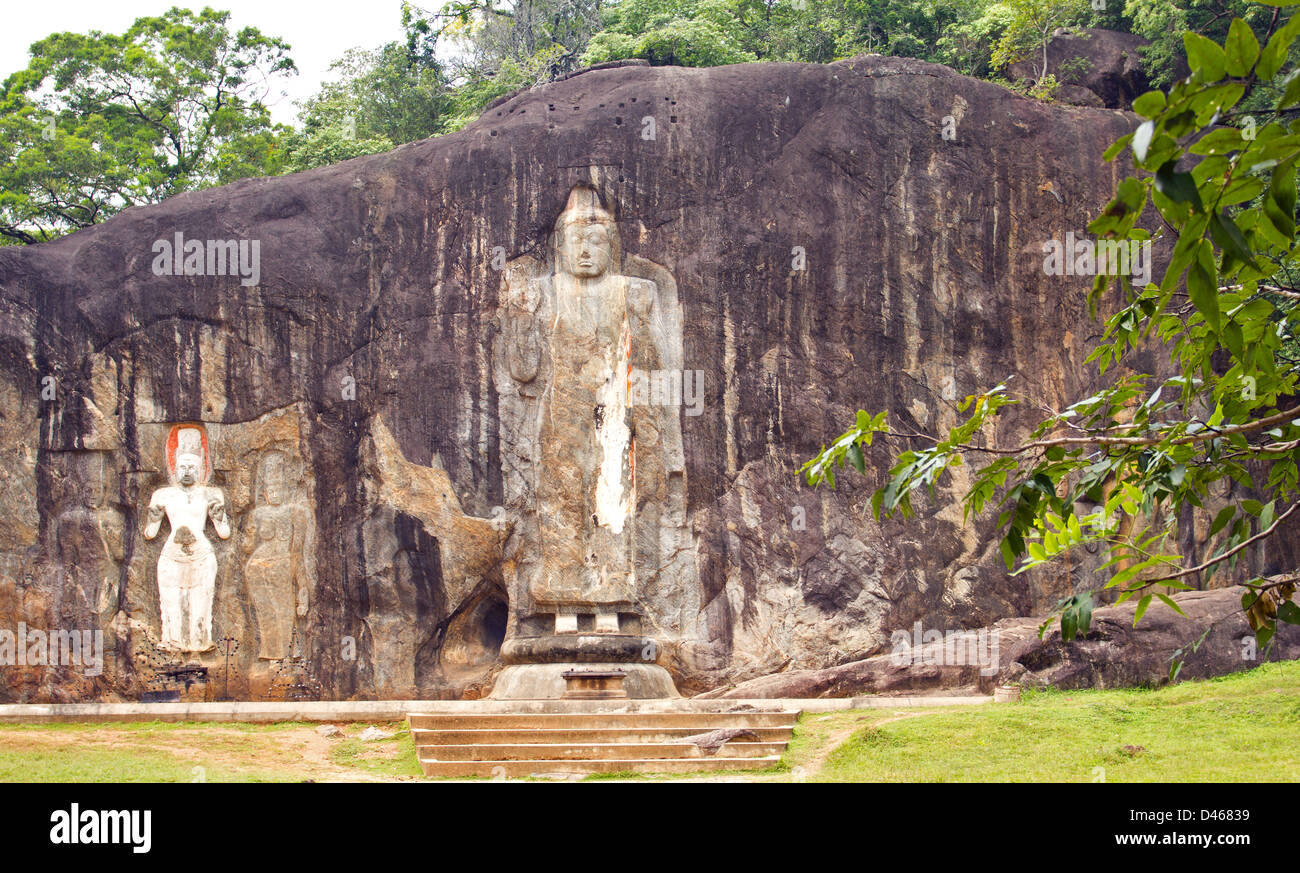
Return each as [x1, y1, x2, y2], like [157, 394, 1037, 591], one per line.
[801, 0, 1300, 654]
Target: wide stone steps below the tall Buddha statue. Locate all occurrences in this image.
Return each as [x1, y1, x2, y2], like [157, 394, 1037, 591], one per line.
[407, 711, 800, 778]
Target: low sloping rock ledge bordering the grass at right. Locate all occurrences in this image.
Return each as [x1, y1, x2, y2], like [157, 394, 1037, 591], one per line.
[698, 587, 1300, 698]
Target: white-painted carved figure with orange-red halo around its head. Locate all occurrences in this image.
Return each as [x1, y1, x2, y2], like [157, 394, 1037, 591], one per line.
[144, 425, 230, 652]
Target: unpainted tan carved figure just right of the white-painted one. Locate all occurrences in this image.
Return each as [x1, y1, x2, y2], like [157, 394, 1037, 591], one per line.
[243, 452, 315, 660]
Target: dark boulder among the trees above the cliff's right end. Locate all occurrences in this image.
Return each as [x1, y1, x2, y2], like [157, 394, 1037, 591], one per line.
[1006, 27, 1151, 109]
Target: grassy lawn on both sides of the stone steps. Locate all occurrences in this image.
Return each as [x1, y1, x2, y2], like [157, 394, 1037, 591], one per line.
[0, 661, 1300, 782]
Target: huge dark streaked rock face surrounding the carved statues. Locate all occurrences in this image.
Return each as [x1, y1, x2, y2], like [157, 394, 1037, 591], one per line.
[0, 57, 1289, 700]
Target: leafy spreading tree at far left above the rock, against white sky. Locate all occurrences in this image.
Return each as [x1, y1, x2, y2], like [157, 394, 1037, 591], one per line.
[0, 8, 294, 243]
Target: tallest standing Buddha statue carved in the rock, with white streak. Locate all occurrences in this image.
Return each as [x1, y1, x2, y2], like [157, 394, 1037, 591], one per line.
[493, 184, 683, 696]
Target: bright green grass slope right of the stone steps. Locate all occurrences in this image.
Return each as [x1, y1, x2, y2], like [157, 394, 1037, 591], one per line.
[821, 661, 1300, 782]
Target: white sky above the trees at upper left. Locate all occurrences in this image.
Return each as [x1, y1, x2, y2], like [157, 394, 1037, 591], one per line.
[0, 0, 426, 123]
